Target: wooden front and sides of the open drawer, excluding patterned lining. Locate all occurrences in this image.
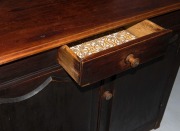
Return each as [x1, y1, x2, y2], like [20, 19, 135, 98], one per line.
[58, 21, 171, 86]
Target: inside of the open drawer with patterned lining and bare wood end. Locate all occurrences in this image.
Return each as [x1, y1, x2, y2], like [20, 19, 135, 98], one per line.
[70, 20, 163, 59]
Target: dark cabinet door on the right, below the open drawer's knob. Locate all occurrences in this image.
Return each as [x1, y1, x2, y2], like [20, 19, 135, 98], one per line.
[105, 46, 175, 131]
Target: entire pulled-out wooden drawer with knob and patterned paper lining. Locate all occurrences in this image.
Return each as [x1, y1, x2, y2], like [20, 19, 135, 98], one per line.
[58, 20, 171, 86]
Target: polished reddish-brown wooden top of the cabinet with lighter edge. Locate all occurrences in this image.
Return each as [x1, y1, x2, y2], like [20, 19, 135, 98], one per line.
[0, 0, 180, 65]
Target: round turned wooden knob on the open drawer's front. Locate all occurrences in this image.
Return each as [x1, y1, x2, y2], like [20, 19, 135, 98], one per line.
[126, 54, 140, 68]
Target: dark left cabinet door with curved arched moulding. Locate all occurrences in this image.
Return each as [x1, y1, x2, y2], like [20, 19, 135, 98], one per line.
[0, 70, 98, 131]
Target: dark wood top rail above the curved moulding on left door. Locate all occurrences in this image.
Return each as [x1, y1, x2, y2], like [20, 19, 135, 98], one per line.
[0, 67, 62, 99]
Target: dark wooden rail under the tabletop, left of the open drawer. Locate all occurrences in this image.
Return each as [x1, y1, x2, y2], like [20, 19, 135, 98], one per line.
[0, 49, 58, 88]
